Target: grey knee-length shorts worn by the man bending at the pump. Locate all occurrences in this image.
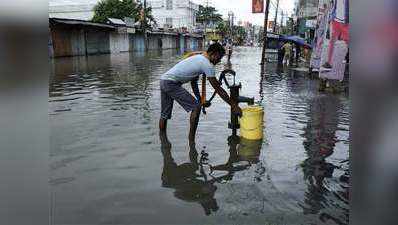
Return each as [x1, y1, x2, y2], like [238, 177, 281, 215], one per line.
[160, 80, 200, 119]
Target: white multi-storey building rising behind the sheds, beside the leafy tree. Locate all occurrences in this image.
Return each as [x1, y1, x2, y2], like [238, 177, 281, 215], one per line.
[147, 0, 199, 30]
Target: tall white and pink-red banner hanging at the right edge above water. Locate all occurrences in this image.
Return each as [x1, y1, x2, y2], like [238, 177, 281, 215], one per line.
[310, 0, 349, 81]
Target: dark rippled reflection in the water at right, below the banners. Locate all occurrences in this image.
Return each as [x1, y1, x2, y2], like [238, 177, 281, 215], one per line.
[301, 95, 348, 224]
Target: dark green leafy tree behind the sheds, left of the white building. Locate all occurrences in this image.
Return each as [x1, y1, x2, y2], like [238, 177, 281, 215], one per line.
[92, 0, 156, 27]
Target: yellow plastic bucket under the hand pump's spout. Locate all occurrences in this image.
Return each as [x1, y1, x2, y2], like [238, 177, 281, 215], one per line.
[239, 105, 264, 140]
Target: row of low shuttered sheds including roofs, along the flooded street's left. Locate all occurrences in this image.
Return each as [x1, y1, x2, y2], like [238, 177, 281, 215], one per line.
[49, 18, 203, 57]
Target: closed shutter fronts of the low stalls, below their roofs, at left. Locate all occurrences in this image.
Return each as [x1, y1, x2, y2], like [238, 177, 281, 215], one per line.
[49, 25, 203, 57]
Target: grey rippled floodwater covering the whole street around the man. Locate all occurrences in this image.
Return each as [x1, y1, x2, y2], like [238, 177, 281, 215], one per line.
[49, 47, 350, 225]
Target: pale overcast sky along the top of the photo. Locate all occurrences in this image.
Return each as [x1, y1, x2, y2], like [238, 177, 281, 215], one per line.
[49, 0, 296, 25]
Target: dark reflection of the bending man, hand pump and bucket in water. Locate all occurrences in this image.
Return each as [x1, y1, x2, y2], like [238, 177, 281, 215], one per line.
[160, 134, 265, 215]
